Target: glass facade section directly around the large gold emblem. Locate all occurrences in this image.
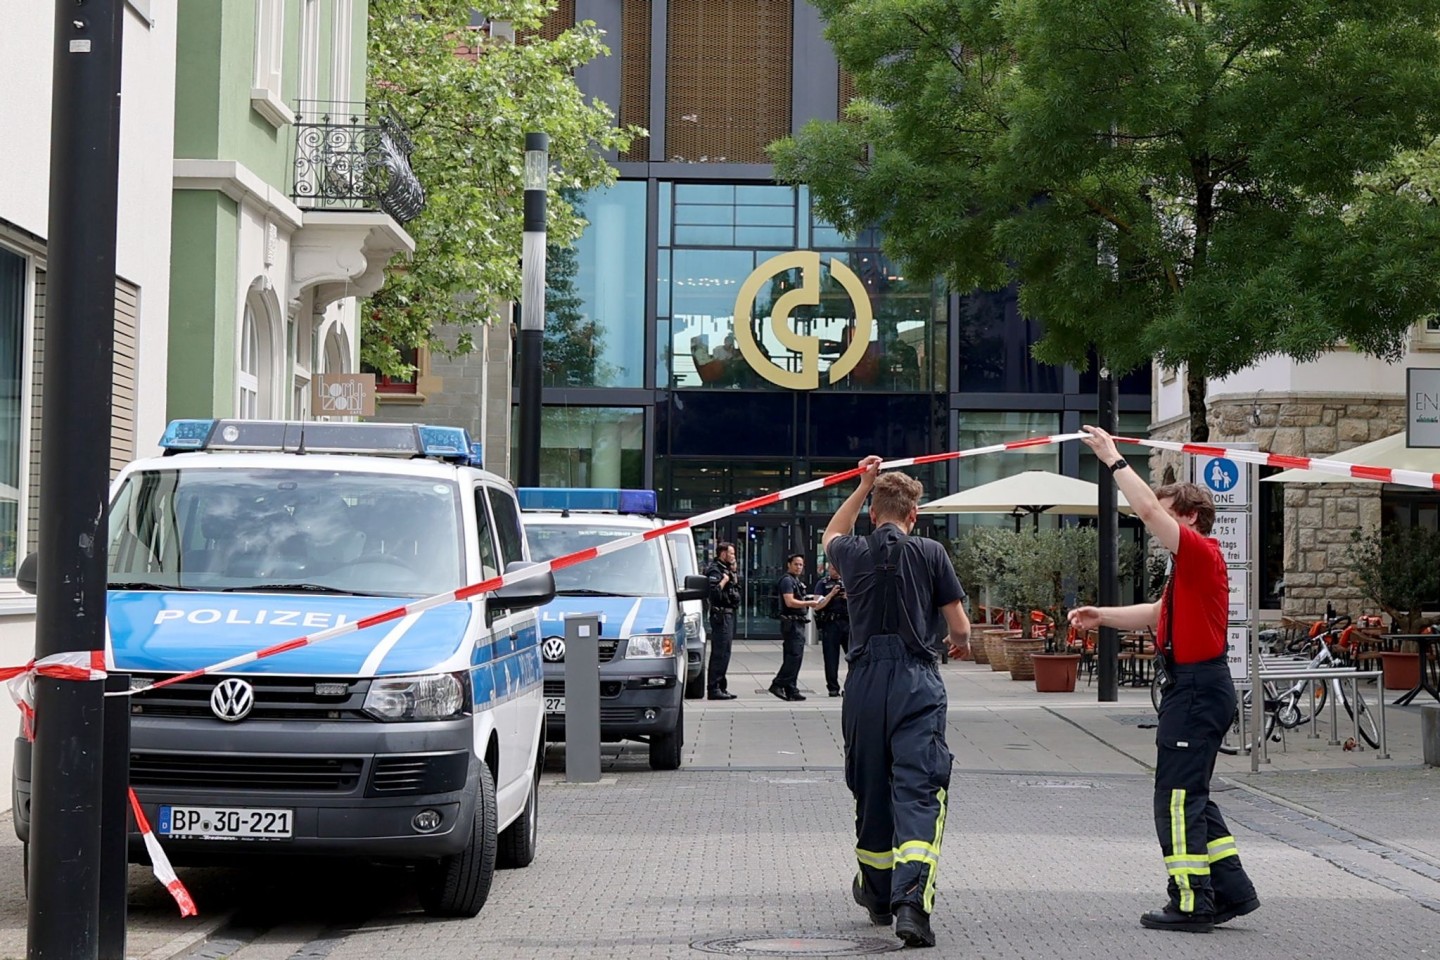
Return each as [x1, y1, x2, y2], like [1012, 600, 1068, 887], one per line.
[655, 183, 946, 391]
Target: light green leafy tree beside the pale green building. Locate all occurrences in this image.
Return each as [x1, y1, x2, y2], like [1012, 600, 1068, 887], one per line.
[360, 0, 642, 376]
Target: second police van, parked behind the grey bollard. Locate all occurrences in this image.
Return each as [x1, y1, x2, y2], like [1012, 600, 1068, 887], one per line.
[518, 486, 708, 770]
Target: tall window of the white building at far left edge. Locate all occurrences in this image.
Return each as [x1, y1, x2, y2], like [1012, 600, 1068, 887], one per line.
[0, 248, 29, 577]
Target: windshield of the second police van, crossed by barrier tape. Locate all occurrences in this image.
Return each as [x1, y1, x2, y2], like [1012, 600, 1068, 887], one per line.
[526, 515, 671, 597]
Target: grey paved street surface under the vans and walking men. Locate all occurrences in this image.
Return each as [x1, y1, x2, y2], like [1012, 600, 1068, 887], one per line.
[0, 643, 1440, 960]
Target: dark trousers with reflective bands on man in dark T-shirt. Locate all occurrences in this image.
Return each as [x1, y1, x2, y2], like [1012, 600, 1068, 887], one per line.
[840, 636, 953, 914]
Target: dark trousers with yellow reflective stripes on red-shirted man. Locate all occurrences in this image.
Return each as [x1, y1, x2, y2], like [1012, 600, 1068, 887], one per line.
[1155, 658, 1256, 914]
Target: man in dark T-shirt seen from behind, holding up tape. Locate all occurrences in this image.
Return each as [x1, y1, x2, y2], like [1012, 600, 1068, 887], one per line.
[824, 456, 971, 947]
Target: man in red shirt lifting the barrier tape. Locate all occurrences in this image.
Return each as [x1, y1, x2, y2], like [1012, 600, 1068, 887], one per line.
[1070, 426, 1260, 933]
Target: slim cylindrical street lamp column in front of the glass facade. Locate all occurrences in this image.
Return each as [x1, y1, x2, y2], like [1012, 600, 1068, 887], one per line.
[518, 134, 550, 486]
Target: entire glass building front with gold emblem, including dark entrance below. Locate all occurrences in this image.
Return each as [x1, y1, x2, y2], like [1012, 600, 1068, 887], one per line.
[512, 176, 1149, 636]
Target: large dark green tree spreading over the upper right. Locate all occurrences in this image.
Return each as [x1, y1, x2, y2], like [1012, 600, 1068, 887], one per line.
[772, 0, 1440, 439]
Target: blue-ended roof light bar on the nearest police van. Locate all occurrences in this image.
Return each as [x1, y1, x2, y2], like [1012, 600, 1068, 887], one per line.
[160, 420, 484, 466]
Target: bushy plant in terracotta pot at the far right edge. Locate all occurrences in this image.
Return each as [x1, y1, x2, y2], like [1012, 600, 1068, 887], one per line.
[1345, 524, 1440, 689]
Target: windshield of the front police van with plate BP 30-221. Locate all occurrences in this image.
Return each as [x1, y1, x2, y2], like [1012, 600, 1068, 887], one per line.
[109, 468, 462, 596]
